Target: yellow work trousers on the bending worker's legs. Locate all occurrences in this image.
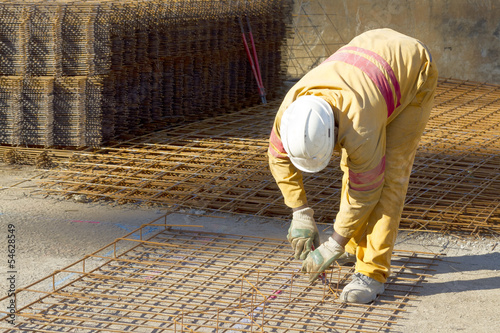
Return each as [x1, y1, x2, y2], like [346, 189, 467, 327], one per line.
[341, 63, 438, 283]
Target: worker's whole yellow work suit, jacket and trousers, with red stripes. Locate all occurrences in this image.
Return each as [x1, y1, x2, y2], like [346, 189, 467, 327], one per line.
[268, 29, 438, 283]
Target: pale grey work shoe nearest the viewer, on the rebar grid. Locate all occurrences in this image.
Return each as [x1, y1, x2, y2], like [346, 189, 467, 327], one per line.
[339, 273, 384, 304]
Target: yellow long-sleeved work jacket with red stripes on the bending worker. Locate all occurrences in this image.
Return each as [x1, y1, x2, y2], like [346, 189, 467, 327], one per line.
[268, 29, 431, 236]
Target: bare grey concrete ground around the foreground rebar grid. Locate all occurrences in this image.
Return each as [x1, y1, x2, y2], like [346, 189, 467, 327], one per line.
[0, 164, 500, 333]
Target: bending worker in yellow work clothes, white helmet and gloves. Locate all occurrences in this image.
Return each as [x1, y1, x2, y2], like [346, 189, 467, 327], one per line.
[268, 29, 438, 303]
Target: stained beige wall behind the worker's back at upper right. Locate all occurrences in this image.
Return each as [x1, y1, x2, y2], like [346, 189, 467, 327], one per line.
[291, 0, 500, 84]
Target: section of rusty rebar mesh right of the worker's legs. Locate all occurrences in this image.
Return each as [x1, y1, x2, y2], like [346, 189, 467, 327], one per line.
[403, 80, 500, 234]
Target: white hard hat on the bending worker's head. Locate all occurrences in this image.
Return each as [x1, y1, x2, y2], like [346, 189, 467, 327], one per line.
[280, 96, 336, 172]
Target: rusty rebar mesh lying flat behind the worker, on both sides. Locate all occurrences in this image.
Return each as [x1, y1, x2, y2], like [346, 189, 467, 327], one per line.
[19, 79, 500, 235]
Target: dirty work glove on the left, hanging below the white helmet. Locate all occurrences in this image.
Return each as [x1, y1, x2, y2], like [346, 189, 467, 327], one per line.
[287, 207, 320, 260]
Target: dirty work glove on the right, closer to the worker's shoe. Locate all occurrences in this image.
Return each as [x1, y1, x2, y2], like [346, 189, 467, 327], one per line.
[302, 237, 345, 283]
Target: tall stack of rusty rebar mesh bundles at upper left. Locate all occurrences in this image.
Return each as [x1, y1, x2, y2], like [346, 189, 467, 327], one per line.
[0, 0, 291, 146]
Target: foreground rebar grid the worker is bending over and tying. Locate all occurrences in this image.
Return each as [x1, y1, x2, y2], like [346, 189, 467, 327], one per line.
[0, 214, 439, 332]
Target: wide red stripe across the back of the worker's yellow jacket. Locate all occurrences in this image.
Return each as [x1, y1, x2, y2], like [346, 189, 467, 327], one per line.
[323, 49, 395, 117]
